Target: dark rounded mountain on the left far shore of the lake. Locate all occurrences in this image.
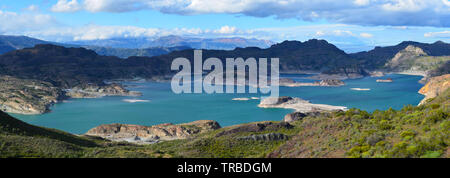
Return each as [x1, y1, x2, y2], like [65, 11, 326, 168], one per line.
[0, 44, 170, 88]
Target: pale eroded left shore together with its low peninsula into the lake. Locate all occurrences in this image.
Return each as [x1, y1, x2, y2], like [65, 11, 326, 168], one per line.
[0, 75, 141, 114]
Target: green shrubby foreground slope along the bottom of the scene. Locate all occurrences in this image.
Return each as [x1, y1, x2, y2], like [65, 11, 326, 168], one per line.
[0, 90, 450, 158]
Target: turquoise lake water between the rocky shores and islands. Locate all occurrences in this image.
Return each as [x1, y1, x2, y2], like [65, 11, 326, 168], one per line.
[13, 74, 423, 134]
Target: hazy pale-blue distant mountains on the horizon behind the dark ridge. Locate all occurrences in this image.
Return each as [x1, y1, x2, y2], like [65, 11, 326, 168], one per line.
[0, 35, 273, 58]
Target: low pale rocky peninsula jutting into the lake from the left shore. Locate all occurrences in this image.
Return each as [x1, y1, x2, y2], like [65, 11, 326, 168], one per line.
[66, 83, 142, 98]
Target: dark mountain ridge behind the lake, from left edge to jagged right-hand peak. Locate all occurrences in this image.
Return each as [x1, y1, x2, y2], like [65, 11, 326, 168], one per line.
[0, 40, 363, 88]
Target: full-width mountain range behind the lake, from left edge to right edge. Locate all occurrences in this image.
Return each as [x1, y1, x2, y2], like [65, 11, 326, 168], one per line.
[0, 37, 450, 87]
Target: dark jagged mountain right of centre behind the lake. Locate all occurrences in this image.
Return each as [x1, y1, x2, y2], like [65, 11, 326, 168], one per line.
[155, 39, 366, 78]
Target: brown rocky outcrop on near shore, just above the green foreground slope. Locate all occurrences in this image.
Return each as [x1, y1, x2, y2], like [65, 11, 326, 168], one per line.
[85, 120, 220, 144]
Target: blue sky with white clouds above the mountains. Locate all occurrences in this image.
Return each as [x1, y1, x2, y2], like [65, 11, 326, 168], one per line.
[0, 0, 450, 52]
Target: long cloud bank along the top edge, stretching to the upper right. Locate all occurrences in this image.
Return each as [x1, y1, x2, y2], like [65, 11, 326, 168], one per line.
[50, 0, 450, 27]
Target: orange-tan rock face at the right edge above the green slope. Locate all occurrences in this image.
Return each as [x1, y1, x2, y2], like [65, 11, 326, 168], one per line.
[419, 74, 450, 105]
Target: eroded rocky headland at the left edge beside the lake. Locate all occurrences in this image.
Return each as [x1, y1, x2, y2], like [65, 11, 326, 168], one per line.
[0, 76, 65, 114]
